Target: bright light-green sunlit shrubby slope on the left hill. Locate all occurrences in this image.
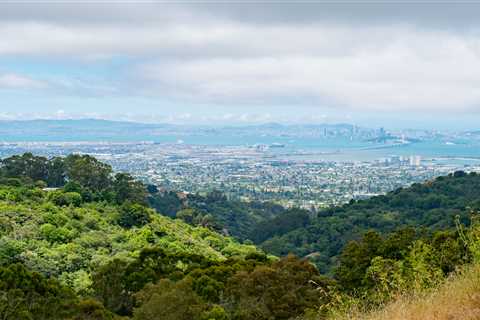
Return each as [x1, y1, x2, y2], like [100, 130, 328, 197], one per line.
[0, 186, 257, 291]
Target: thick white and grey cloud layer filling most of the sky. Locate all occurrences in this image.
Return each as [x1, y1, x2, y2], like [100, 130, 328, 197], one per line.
[0, 2, 480, 118]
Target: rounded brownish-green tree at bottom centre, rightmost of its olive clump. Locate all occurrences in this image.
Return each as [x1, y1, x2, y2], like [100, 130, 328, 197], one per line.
[227, 256, 331, 320]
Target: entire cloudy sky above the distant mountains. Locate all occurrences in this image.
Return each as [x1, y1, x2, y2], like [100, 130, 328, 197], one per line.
[0, 0, 480, 129]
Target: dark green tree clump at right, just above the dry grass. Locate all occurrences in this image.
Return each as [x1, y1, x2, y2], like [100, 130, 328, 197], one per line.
[335, 228, 470, 293]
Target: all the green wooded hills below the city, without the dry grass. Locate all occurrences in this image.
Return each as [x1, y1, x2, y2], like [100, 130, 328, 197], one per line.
[0, 154, 480, 320]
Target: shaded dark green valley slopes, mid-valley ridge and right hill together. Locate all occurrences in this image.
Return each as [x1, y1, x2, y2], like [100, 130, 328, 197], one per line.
[150, 171, 480, 274]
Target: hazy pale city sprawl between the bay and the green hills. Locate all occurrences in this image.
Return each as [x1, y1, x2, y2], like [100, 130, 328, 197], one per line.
[0, 142, 480, 208]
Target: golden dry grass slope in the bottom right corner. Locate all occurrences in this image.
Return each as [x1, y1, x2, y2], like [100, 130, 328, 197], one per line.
[334, 265, 480, 320]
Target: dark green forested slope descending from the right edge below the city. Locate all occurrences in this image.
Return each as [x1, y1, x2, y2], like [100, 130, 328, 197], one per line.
[261, 172, 480, 273]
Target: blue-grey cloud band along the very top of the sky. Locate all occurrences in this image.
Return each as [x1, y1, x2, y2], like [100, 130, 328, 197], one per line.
[0, 0, 480, 28]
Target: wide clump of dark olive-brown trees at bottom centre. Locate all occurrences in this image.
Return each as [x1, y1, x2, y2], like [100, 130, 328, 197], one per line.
[124, 252, 332, 320]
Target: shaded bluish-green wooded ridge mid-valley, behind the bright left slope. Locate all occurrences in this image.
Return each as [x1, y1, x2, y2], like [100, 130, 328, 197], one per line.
[149, 191, 311, 243]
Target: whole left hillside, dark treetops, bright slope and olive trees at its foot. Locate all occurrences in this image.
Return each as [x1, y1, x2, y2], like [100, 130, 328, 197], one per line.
[0, 154, 333, 320]
